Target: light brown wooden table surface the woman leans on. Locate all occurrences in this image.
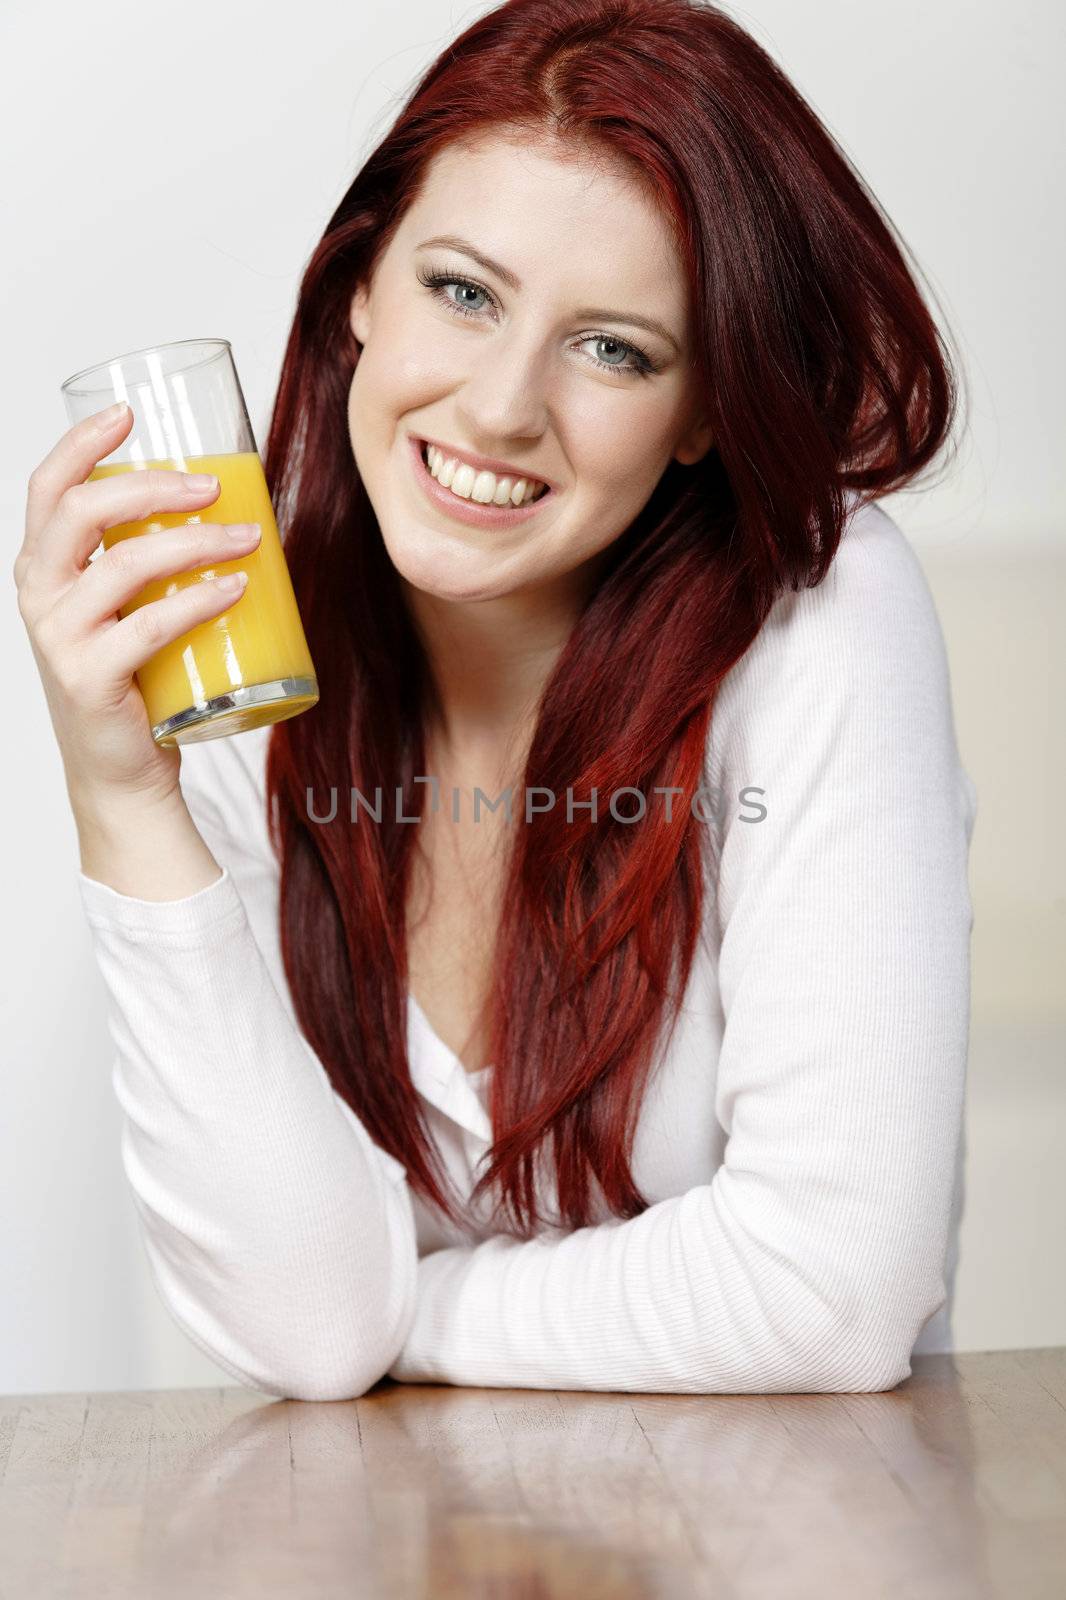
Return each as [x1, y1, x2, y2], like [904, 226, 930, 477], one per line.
[0, 1349, 1066, 1600]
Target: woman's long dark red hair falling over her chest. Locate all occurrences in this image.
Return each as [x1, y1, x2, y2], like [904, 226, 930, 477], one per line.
[264, 0, 957, 1235]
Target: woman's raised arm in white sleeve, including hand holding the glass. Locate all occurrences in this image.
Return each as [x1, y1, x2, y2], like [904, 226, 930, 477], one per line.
[14, 403, 418, 1400]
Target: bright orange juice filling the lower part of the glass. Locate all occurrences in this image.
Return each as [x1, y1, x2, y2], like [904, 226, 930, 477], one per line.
[90, 451, 319, 746]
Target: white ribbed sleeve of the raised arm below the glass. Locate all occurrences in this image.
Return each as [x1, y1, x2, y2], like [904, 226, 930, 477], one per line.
[78, 730, 416, 1400]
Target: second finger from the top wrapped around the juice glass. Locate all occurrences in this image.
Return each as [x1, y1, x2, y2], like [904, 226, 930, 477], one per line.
[27, 467, 221, 600]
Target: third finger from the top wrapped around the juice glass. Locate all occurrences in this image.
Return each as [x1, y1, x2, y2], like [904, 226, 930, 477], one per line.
[48, 522, 261, 642]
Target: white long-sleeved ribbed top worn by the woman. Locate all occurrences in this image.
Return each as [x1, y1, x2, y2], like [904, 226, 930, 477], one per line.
[78, 507, 976, 1400]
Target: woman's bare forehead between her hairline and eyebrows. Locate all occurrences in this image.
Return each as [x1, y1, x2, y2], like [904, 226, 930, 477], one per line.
[397, 134, 685, 308]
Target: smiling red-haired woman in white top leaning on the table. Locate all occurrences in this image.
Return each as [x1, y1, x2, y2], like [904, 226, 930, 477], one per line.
[16, 0, 975, 1400]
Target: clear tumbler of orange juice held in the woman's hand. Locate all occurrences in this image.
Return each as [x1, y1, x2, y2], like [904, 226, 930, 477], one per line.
[61, 339, 319, 746]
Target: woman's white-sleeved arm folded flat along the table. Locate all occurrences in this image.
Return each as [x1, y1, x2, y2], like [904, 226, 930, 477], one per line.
[389, 507, 975, 1394]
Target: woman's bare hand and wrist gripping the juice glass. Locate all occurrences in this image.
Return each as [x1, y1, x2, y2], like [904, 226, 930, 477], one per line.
[14, 406, 259, 802]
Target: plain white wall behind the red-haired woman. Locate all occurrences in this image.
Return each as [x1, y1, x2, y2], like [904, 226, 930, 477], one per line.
[0, 0, 1066, 1394]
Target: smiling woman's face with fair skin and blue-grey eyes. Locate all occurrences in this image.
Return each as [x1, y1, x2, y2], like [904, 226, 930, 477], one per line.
[347, 136, 711, 600]
